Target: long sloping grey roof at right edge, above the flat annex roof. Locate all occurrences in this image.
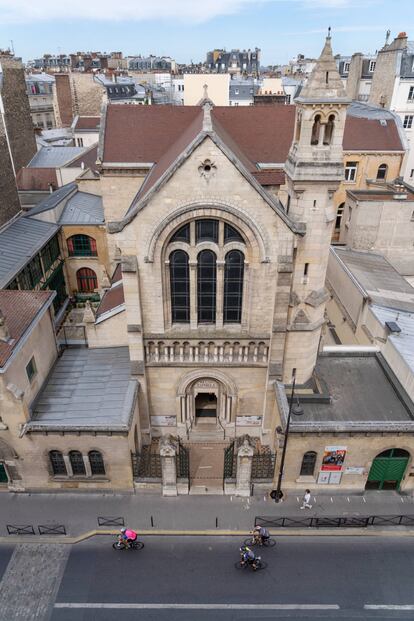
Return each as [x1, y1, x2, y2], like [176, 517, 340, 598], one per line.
[331, 246, 414, 315]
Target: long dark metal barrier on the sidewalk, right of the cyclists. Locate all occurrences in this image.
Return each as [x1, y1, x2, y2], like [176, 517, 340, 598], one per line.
[254, 515, 414, 528]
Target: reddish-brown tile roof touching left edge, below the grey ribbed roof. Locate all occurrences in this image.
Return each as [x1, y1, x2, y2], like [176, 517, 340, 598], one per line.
[0, 289, 55, 367]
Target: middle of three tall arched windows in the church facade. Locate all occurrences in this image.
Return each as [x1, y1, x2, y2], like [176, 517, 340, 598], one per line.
[197, 248, 217, 323]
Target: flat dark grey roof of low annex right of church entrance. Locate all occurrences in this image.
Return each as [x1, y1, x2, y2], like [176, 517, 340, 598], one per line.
[276, 354, 414, 433]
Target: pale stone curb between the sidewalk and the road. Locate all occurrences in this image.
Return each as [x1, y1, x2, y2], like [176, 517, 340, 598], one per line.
[0, 528, 414, 545]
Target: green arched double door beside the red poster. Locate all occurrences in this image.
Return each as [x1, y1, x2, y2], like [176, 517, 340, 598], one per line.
[365, 448, 410, 490]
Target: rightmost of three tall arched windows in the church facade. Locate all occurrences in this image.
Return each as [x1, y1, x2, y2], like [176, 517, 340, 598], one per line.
[223, 250, 244, 323]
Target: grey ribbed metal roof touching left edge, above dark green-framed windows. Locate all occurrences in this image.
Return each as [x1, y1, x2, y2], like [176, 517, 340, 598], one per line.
[0, 217, 59, 288]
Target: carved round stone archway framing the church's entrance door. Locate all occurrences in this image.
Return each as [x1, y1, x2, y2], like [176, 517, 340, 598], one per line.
[177, 369, 237, 428]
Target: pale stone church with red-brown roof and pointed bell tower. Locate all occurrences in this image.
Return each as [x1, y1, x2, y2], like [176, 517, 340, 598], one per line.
[3, 37, 414, 495]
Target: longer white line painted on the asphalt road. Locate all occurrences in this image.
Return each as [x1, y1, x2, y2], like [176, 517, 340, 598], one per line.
[55, 602, 339, 610]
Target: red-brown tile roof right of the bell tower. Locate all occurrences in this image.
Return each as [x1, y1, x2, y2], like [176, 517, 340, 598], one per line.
[342, 116, 404, 151]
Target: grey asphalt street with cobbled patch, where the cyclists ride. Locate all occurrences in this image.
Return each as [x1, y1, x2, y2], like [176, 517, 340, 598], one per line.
[0, 536, 414, 621]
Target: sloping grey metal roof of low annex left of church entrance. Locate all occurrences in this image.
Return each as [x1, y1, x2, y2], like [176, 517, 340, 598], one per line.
[27, 347, 139, 432]
